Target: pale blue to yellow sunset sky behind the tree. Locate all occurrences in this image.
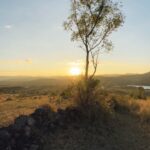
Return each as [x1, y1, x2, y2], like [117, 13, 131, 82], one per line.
[0, 0, 150, 76]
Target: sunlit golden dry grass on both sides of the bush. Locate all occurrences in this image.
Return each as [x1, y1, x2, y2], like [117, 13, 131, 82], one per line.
[0, 89, 150, 127]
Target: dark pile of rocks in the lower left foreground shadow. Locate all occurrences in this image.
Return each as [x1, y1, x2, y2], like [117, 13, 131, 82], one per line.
[0, 106, 81, 150]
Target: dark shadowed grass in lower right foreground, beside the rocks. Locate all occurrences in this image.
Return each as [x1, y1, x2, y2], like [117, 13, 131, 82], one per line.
[44, 114, 150, 150]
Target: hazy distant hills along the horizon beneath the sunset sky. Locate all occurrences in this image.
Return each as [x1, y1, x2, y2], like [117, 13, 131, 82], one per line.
[0, 72, 150, 87]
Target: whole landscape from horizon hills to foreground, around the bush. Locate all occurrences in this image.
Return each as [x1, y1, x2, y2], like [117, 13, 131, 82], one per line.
[0, 73, 150, 150]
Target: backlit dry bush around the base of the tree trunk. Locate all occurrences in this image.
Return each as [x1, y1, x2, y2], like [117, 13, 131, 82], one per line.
[74, 79, 112, 122]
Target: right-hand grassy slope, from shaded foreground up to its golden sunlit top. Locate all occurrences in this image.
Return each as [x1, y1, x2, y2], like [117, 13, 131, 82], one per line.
[44, 97, 150, 150]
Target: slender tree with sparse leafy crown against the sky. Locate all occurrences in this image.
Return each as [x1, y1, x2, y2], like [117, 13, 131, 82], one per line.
[64, 0, 124, 81]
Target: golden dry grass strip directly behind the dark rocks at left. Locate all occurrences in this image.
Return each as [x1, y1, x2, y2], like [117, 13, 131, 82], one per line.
[0, 94, 70, 127]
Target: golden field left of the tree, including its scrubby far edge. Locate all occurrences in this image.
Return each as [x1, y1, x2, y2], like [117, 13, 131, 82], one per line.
[0, 87, 72, 127]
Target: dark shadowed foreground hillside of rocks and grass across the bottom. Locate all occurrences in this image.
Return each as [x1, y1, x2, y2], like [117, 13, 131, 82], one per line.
[0, 101, 150, 150]
